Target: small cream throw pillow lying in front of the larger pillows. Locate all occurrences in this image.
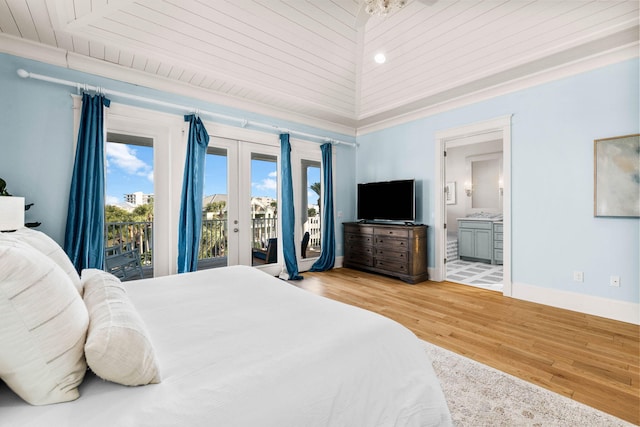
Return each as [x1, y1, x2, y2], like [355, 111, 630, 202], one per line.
[81, 269, 160, 386]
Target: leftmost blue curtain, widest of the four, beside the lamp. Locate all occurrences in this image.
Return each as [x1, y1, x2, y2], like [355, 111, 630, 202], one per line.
[64, 93, 111, 272]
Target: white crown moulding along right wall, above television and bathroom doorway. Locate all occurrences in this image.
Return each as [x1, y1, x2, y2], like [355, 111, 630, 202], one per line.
[356, 43, 640, 136]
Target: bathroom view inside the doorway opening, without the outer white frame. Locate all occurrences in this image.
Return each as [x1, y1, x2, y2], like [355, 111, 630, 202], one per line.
[444, 140, 504, 292]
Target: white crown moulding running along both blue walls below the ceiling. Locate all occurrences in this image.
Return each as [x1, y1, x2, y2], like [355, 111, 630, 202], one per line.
[0, 33, 640, 137]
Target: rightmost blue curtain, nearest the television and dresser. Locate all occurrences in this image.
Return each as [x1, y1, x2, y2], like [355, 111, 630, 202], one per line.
[310, 144, 336, 271]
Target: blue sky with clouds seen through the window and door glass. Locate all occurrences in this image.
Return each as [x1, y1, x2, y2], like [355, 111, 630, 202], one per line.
[106, 142, 320, 204]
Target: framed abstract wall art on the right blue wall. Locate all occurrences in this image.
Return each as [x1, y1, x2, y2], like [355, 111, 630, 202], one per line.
[594, 135, 640, 217]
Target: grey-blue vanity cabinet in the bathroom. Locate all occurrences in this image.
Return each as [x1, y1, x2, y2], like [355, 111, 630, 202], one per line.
[458, 220, 494, 263]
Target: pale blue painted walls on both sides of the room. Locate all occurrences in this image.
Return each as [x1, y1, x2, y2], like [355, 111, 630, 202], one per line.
[0, 54, 640, 303]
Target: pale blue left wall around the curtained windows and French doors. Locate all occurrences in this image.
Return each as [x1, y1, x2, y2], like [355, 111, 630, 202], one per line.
[0, 54, 355, 244]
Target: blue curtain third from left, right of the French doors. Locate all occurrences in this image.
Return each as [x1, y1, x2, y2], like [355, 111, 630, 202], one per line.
[280, 133, 303, 280]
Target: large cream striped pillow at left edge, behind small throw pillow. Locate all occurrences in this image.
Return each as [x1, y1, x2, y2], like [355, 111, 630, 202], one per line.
[0, 239, 89, 405]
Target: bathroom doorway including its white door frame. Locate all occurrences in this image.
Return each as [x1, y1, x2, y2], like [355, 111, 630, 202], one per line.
[432, 116, 511, 296]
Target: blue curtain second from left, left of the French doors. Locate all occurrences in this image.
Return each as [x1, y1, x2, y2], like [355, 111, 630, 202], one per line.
[178, 114, 209, 273]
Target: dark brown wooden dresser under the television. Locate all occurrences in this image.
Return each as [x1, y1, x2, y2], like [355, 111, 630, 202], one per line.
[342, 222, 428, 283]
